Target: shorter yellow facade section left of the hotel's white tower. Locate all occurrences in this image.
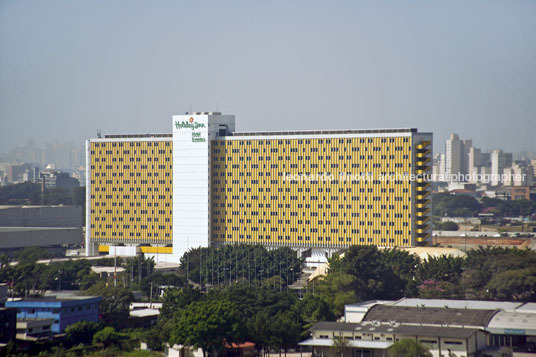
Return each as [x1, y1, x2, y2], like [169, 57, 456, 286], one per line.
[89, 138, 173, 245]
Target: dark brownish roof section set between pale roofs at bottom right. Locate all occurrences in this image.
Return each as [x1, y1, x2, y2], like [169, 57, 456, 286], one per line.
[363, 305, 497, 327]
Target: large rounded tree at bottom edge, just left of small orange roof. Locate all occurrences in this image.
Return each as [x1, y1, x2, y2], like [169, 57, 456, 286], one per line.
[169, 299, 245, 355]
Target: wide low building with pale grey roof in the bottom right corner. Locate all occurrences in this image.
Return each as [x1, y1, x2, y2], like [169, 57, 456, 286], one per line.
[338, 298, 536, 356]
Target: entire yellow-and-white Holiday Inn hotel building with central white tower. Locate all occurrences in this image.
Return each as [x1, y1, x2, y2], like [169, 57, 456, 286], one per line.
[86, 112, 432, 262]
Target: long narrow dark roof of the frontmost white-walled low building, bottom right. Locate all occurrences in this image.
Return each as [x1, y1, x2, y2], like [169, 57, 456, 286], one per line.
[311, 321, 478, 338]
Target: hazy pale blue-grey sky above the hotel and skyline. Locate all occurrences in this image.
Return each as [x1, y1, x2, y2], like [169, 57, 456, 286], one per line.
[0, 0, 536, 151]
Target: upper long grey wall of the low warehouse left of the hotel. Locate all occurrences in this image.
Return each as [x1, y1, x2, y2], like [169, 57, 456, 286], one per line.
[0, 206, 82, 227]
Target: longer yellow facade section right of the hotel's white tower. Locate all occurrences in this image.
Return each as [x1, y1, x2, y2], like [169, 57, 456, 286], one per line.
[211, 136, 430, 247]
